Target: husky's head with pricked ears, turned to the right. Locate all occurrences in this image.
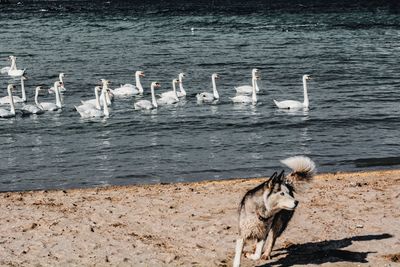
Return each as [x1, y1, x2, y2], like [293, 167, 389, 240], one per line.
[263, 172, 299, 211]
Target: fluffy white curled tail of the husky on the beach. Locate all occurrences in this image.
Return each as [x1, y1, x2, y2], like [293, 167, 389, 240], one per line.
[281, 156, 316, 181]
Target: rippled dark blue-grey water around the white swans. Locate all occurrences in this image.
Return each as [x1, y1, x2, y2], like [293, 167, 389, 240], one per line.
[0, 1, 400, 191]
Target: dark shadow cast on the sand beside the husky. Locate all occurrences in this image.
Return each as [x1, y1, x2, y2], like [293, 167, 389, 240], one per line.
[261, 234, 393, 267]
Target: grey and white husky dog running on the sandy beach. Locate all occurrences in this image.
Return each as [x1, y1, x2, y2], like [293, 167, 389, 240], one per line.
[233, 156, 315, 267]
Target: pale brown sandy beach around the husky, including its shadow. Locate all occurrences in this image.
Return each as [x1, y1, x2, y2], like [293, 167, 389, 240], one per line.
[0, 171, 400, 266]
